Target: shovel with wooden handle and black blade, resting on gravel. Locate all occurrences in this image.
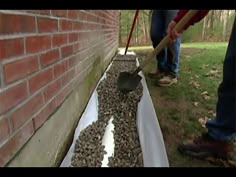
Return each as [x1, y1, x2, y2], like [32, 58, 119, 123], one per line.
[117, 10, 198, 93]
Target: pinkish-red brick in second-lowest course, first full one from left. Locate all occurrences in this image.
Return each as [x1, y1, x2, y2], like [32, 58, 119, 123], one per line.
[11, 93, 43, 130]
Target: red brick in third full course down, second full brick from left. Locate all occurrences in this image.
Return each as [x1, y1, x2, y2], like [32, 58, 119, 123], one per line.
[40, 49, 59, 67]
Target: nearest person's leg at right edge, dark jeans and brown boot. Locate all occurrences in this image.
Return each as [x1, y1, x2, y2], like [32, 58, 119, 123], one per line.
[178, 19, 236, 158]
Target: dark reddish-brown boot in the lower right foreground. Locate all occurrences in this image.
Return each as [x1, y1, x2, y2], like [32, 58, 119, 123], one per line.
[178, 133, 234, 160]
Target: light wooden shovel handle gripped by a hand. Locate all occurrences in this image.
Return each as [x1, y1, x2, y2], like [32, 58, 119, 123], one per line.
[138, 10, 198, 70]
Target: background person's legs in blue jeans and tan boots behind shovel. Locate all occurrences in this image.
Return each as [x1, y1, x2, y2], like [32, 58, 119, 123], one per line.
[148, 10, 181, 86]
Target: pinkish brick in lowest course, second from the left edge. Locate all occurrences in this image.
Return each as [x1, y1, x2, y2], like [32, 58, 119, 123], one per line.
[33, 99, 57, 130]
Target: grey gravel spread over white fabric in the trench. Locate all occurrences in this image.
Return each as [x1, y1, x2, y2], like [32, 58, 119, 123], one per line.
[72, 55, 143, 167]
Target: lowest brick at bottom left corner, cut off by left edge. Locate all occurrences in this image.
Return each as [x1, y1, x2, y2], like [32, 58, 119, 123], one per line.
[0, 121, 34, 167]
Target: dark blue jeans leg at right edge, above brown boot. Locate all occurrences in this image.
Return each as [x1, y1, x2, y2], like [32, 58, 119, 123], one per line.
[206, 16, 236, 141]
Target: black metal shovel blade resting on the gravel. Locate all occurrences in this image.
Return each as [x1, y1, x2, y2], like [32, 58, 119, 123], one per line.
[117, 72, 142, 93]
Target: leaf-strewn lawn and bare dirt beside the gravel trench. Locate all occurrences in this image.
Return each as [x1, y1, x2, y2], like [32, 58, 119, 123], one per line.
[129, 43, 236, 167]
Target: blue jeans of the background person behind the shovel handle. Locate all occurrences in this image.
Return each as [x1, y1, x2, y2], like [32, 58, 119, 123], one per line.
[150, 10, 181, 76]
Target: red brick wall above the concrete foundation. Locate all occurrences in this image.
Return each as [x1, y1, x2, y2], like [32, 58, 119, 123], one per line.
[0, 10, 119, 166]
